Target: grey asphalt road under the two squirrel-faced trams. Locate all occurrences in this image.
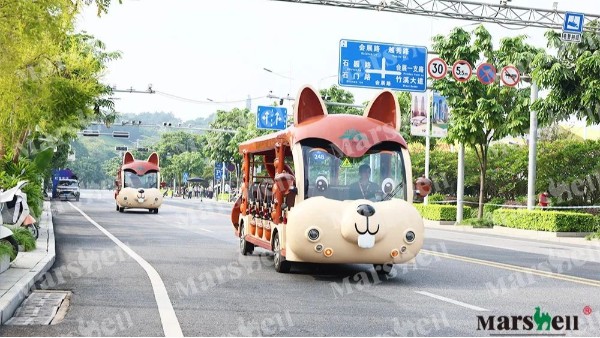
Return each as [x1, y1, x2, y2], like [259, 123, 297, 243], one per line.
[0, 191, 600, 336]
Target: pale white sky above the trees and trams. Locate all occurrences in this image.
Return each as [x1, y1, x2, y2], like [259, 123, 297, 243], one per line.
[77, 0, 600, 122]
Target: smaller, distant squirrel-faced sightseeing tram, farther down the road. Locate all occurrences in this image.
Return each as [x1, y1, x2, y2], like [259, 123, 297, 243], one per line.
[115, 151, 163, 214]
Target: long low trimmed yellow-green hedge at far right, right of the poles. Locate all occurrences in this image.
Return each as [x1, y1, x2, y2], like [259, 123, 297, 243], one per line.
[493, 209, 596, 232]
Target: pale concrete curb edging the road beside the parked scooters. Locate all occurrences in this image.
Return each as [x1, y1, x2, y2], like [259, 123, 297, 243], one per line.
[0, 201, 56, 325]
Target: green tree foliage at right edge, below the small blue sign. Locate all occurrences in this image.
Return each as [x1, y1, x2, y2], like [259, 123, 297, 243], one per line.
[532, 21, 600, 125]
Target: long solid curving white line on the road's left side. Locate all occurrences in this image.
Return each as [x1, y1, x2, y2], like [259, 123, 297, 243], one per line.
[69, 202, 183, 337]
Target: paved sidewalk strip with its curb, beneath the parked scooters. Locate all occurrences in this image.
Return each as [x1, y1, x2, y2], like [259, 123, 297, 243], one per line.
[0, 201, 56, 325]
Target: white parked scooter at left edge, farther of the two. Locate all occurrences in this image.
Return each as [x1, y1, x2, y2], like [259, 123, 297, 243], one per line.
[0, 181, 39, 239]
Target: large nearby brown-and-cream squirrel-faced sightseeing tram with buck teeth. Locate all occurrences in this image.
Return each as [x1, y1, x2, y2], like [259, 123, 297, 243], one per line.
[231, 86, 431, 273]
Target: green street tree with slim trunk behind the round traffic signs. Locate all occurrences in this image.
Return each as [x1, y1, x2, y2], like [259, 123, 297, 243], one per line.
[433, 26, 541, 218]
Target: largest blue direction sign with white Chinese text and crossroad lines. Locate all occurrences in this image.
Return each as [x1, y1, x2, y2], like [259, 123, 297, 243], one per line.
[338, 39, 427, 92]
